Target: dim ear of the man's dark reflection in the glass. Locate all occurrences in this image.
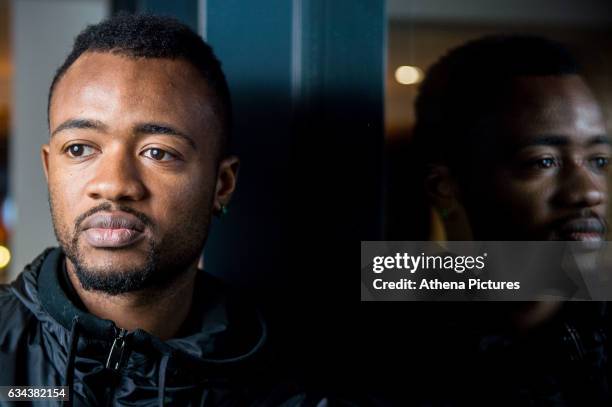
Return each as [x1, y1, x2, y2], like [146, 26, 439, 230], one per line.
[425, 164, 459, 217]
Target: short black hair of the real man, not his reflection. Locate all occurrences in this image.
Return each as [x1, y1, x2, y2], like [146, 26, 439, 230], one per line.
[47, 13, 232, 153]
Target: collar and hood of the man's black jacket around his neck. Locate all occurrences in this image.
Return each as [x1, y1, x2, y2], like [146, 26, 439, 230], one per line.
[30, 248, 267, 365]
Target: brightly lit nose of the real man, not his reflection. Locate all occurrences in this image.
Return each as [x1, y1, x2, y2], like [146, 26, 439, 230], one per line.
[86, 146, 146, 202]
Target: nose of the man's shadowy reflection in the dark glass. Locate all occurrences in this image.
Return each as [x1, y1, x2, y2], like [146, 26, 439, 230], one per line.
[558, 162, 607, 208]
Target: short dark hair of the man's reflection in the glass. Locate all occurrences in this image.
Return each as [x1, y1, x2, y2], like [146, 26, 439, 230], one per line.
[413, 35, 580, 176]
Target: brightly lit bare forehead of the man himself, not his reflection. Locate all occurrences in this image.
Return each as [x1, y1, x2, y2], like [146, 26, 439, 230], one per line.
[49, 52, 214, 135]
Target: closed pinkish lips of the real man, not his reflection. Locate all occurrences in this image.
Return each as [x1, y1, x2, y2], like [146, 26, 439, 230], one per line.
[81, 212, 145, 248]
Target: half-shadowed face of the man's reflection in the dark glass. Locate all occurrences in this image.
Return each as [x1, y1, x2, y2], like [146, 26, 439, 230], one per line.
[466, 75, 612, 241]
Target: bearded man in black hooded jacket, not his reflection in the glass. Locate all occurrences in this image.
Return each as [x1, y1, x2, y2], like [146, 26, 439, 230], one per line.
[0, 15, 298, 406]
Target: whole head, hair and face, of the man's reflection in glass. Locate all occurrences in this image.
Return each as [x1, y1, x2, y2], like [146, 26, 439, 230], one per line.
[416, 38, 611, 241]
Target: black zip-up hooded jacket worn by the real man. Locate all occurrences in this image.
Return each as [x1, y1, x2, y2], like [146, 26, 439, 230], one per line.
[0, 249, 304, 406]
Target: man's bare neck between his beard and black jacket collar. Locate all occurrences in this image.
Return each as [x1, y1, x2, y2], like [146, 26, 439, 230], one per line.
[65, 260, 197, 340]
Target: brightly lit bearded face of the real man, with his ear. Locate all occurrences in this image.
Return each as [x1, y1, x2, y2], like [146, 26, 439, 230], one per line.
[42, 52, 237, 294]
